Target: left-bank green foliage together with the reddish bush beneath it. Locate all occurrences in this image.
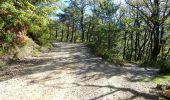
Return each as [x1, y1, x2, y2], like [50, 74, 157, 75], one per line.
[0, 0, 58, 56]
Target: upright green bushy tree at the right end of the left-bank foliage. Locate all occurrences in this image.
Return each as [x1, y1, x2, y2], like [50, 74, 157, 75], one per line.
[29, 0, 55, 45]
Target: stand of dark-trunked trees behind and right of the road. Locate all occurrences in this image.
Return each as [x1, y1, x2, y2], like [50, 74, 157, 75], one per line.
[56, 0, 170, 72]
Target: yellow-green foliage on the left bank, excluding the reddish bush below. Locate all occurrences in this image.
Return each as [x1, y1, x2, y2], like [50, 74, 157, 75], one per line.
[0, 0, 57, 45]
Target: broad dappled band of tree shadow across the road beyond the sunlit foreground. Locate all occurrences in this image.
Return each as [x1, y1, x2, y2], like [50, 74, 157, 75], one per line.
[0, 43, 156, 82]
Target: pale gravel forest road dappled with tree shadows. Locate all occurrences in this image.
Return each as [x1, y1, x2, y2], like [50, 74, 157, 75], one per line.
[0, 43, 158, 100]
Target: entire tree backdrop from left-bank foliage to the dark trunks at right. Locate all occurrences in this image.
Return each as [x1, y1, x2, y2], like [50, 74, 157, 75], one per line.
[0, 0, 170, 72]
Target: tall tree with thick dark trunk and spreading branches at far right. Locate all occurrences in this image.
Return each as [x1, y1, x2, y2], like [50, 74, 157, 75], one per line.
[126, 0, 170, 60]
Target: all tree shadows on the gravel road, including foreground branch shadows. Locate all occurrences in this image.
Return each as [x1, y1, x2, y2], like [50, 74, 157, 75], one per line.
[0, 43, 157, 100]
